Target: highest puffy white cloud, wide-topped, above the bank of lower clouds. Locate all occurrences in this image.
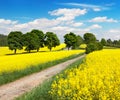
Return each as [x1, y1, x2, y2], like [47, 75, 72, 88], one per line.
[49, 8, 87, 21]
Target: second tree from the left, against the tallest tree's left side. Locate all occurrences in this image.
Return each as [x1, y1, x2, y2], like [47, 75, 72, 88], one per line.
[23, 32, 39, 53]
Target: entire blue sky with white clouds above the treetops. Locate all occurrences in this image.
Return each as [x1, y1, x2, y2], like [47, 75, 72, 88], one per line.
[0, 0, 120, 41]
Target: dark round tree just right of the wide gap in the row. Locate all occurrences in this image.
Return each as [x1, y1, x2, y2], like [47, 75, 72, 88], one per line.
[64, 32, 77, 50]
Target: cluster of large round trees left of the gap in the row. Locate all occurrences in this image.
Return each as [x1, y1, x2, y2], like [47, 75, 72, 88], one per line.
[7, 29, 60, 53]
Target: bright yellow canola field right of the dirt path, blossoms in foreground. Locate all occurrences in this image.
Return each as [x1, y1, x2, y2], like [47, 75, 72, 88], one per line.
[49, 49, 120, 100]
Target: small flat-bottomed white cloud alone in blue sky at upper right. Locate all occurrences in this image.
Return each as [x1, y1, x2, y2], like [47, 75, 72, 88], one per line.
[89, 16, 118, 23]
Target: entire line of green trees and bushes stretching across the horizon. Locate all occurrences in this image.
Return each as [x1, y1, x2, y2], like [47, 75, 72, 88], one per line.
[0, 29, 120, 54]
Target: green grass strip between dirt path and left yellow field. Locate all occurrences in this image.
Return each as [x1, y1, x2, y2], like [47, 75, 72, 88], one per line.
[0, 53, 83, 85]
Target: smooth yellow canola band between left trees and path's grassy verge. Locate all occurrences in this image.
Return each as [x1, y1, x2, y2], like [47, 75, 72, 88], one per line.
[0, 50, 84, 73]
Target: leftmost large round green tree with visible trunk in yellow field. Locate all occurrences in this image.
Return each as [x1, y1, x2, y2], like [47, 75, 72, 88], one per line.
[7, 31, 23, 54]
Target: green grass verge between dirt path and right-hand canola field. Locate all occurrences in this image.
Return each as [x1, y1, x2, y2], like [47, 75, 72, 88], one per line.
[16, 55, 84, 100]
